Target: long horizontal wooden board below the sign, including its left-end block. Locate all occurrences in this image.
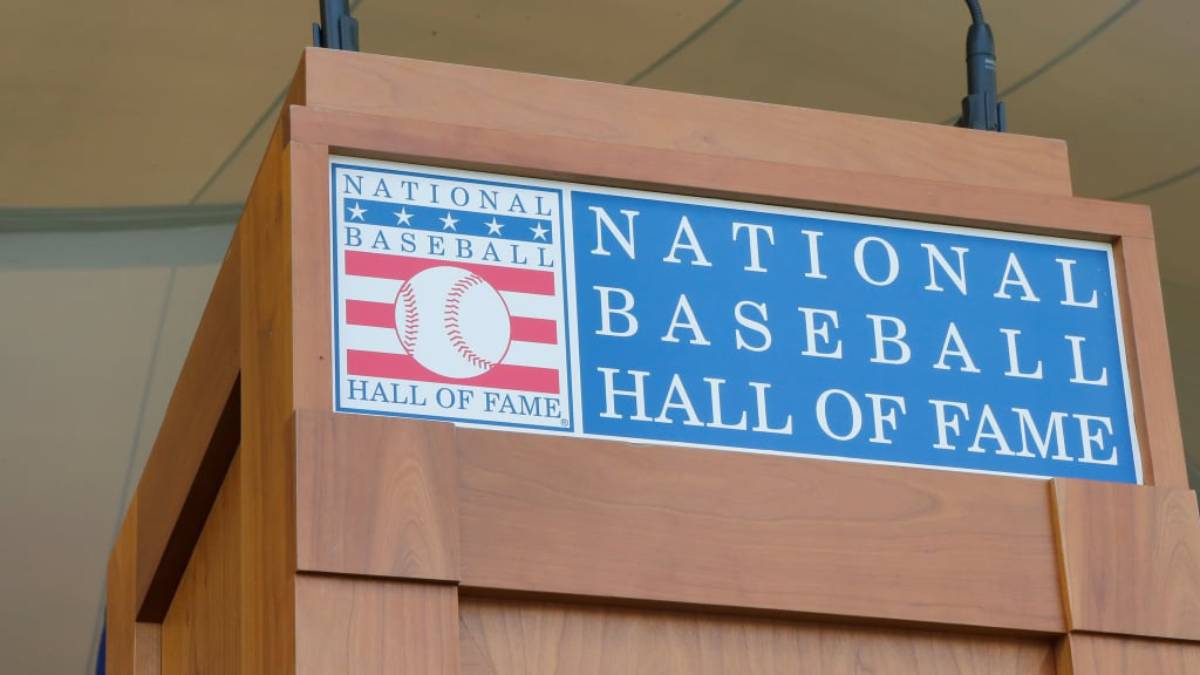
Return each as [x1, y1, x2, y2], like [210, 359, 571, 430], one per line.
[288, 411, 1066, 633]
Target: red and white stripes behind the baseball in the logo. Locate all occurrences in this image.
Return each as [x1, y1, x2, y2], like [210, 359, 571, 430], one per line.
[338, 251, 563, 394]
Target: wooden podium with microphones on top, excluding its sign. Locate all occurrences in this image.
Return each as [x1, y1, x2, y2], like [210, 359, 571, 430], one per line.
[108, 49, 1200, 675]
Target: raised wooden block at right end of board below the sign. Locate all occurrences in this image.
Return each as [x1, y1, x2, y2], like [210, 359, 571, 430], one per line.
[1054, 479, 1200, 640]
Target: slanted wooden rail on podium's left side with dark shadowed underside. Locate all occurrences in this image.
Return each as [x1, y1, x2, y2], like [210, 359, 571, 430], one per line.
[137, 234, 240, 621]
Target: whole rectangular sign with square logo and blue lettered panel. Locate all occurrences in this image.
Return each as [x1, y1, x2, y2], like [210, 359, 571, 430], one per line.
[330, 157, 1141, 483]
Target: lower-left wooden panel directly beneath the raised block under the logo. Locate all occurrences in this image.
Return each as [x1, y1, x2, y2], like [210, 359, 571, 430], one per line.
[295, 574, 458, 675]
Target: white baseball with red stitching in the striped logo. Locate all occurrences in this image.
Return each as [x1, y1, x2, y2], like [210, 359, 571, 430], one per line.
[396, 265, 511, 380]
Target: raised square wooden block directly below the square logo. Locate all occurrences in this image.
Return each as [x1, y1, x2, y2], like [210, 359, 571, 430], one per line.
[295, 411, 458, 581]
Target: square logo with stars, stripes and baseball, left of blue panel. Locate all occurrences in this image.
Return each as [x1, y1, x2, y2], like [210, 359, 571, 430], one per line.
[331, 162, 571, 429]
